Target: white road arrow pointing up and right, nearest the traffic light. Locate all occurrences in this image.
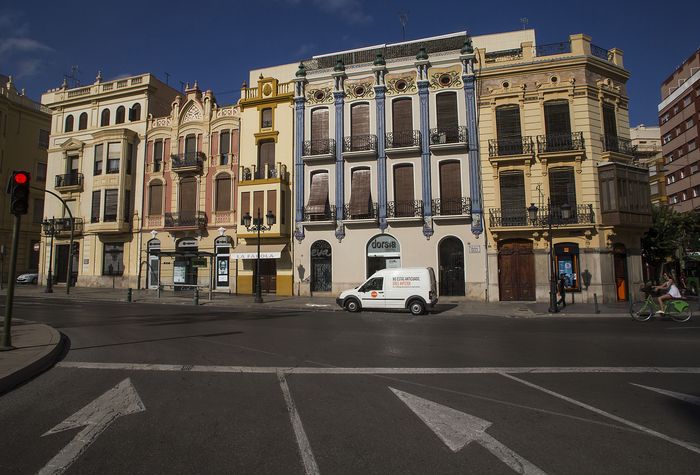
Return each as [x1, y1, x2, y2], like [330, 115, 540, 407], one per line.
[39, 378, 146, 475]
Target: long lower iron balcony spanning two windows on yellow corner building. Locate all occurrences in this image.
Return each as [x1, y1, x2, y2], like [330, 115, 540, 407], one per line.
[489, 204, 595, 228]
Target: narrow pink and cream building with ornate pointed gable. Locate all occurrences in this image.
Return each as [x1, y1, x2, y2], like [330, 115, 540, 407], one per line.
[141, 83, 239, 293]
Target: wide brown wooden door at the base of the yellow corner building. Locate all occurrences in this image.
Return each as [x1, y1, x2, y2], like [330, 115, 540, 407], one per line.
[498, 239, 535, 301]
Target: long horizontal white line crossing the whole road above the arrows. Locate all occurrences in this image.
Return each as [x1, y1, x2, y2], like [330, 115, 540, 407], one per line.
[56, 361, 700, 375]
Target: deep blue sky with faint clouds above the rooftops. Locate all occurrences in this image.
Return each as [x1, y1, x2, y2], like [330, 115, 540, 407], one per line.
[0, 0, 700, 126]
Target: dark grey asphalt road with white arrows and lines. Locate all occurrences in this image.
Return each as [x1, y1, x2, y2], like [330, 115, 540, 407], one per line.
[0, 298, 700, 474]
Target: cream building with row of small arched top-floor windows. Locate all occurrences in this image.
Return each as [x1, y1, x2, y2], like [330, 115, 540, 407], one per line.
[40, 74, 178, 288]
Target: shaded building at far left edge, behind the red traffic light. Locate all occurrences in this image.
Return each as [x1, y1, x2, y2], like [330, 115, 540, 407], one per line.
[0, 75, 51, 283]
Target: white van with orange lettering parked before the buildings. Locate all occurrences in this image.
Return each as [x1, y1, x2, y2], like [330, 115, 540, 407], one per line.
[335, 267, 438, 315]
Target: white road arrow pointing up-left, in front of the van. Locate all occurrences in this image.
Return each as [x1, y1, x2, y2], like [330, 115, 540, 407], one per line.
[389, 387, 545, 475]
